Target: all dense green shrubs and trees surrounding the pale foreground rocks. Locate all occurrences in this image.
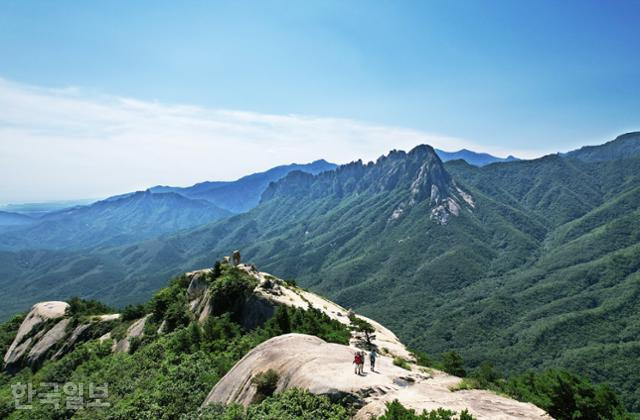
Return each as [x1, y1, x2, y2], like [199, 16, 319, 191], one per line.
[0, 265, 629, 420]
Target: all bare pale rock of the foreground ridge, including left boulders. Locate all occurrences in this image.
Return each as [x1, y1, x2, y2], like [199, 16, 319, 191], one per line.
[4, 261, 551, 419]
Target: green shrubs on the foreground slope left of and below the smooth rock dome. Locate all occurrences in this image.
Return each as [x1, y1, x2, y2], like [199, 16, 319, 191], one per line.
[0, 267, 349, 419]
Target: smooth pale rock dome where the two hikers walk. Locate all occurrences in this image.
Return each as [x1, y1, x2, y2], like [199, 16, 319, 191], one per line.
[204, 334, 551, 420]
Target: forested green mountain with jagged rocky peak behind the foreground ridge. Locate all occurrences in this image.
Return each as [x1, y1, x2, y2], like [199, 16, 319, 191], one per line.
[0, 133, 640, 411]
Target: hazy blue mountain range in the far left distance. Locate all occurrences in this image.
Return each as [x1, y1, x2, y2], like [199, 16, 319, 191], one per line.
[0, 160, 336, 251]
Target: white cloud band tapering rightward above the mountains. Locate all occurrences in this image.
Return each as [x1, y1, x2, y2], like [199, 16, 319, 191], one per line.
[0, 79, 540, 203]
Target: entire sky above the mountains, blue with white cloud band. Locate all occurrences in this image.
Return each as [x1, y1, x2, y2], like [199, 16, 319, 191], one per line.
[0, 0, 640, 203]
